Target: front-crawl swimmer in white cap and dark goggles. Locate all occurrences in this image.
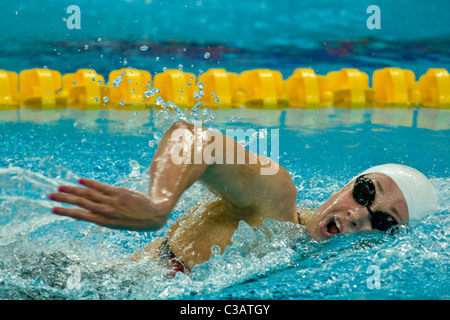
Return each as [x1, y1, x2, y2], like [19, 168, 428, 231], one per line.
[49, 121, 437, 272]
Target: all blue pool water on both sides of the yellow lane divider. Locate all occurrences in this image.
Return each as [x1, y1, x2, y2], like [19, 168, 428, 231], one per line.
[0, 0, 450, 299]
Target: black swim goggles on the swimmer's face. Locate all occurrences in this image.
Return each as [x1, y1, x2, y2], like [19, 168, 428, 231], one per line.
[352, 176, 398, 231]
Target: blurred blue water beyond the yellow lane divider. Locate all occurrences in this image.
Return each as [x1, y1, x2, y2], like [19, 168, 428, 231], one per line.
[0, 0, 450, 79]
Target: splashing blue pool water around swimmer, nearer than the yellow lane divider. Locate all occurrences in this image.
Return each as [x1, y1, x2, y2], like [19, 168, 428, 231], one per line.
[0, 108, 450, 299]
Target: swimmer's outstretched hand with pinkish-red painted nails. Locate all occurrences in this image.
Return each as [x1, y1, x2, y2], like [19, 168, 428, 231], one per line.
[49, 179, 171, 231]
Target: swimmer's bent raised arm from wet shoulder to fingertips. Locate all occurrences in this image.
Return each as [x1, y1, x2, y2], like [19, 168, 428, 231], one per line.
[50, 121, 297, 231]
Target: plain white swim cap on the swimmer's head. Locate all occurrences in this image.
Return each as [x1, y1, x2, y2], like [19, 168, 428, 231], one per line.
[361, 163, 438, 220]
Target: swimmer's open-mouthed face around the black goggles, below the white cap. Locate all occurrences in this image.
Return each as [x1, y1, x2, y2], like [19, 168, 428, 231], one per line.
[305, 173, 409, 241]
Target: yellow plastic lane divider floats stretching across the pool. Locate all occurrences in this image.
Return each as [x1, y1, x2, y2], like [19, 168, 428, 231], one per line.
[0, 68, 450, 110]
